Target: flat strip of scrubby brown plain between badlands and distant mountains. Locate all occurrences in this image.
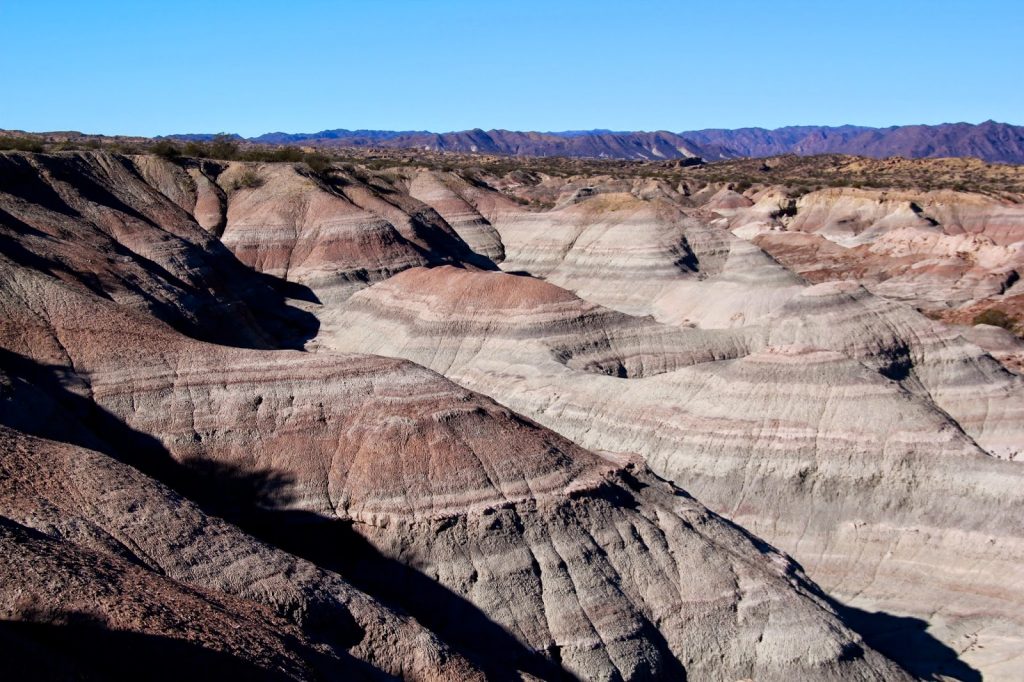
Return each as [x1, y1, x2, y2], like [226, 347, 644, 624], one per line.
[6, 133, 1024, 202]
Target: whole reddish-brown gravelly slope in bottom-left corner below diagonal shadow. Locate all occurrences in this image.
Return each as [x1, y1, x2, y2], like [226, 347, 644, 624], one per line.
[0, 428, 480, 679]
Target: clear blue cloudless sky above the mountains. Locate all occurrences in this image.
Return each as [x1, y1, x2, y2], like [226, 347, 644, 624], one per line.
[0, 0, 1024, 135]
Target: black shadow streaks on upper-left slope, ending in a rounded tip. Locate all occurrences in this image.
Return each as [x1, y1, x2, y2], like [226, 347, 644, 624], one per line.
[0, 155, 319, 349]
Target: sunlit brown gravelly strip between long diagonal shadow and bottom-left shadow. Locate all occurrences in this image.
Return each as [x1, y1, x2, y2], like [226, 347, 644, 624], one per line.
[0, 428, 479, 679]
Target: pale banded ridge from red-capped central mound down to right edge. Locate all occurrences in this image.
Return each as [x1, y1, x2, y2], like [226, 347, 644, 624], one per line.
[324, 268, 1024, 665]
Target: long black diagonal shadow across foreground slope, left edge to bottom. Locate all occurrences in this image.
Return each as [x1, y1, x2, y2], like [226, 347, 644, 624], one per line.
[0, 349, 572, 680]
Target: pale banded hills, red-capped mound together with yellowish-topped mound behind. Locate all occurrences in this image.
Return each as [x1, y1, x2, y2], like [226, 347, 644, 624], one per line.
[309, 168, 1024, 678]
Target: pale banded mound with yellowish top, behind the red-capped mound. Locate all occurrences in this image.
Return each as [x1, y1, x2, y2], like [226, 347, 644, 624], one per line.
[492, 187, 802, 328]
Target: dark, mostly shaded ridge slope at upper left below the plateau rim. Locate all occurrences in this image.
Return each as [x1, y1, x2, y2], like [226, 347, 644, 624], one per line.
[0, 153, 315, 348]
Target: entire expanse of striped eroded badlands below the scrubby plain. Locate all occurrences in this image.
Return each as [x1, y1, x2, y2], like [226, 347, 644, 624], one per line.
[0, 144, 1024, 680]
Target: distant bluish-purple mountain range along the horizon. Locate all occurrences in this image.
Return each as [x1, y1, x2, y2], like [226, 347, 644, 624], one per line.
[169, 121, 1024, 164]
